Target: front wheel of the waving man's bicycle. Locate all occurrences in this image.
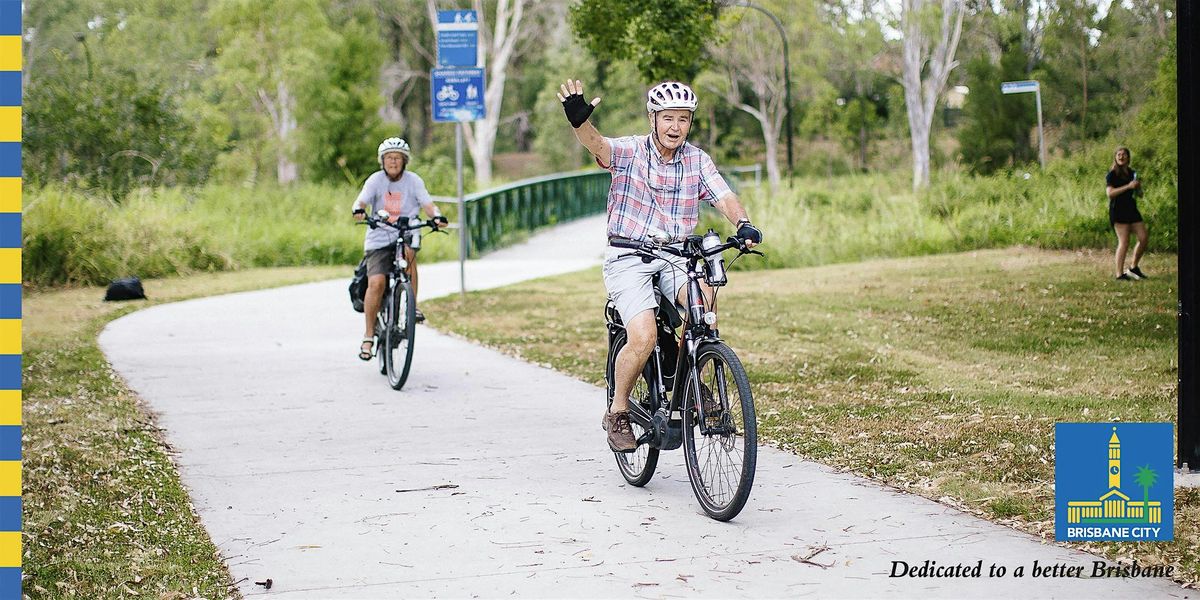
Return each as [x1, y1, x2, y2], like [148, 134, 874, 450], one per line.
[682, 343, 758, 521]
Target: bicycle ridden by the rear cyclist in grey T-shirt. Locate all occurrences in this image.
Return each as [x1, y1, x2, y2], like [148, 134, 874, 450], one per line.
[362, 210, 439, 390]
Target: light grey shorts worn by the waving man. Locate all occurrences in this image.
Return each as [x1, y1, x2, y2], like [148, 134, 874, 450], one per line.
[604, 246, 688, 323]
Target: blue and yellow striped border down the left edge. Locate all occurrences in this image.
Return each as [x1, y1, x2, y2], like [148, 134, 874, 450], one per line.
[0, 0, 22, 599]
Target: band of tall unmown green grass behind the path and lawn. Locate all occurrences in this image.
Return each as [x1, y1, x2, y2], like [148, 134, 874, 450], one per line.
[23, 149, 1178, 286]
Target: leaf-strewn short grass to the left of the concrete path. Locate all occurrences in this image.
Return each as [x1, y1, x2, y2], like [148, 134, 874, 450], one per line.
[22, 266, 348, 599]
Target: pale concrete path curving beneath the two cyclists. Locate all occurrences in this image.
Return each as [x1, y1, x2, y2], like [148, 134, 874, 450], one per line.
[100, 218, 1188, 599]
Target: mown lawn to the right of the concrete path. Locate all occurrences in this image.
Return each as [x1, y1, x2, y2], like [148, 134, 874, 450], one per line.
[426, 247, 1200, 581]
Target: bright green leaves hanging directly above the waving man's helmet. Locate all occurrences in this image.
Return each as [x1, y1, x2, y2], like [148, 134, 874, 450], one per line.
[570, 0, 718, 82]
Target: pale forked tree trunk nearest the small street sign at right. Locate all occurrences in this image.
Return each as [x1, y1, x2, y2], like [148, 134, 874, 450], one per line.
[900, 0, 965, 190]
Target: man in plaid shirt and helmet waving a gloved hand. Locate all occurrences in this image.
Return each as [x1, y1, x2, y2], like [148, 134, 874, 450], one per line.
[558, 80, 762, 452]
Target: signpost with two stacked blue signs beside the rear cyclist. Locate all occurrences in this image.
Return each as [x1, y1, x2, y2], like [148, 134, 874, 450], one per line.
[430, 11, 487, 295]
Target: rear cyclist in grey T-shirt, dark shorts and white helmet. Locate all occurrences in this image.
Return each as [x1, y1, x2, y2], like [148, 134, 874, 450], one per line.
[352, 138, 446, 360]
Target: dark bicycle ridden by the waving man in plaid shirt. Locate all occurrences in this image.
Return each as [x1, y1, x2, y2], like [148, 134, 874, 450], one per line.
[605, 229, 762, 521]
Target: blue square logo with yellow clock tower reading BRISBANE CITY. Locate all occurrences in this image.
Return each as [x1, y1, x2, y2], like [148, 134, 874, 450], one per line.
[1054, 422, 1175, 541]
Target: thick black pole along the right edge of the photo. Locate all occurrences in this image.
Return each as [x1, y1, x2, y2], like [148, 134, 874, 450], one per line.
[1176, 2, 1200, 472]
